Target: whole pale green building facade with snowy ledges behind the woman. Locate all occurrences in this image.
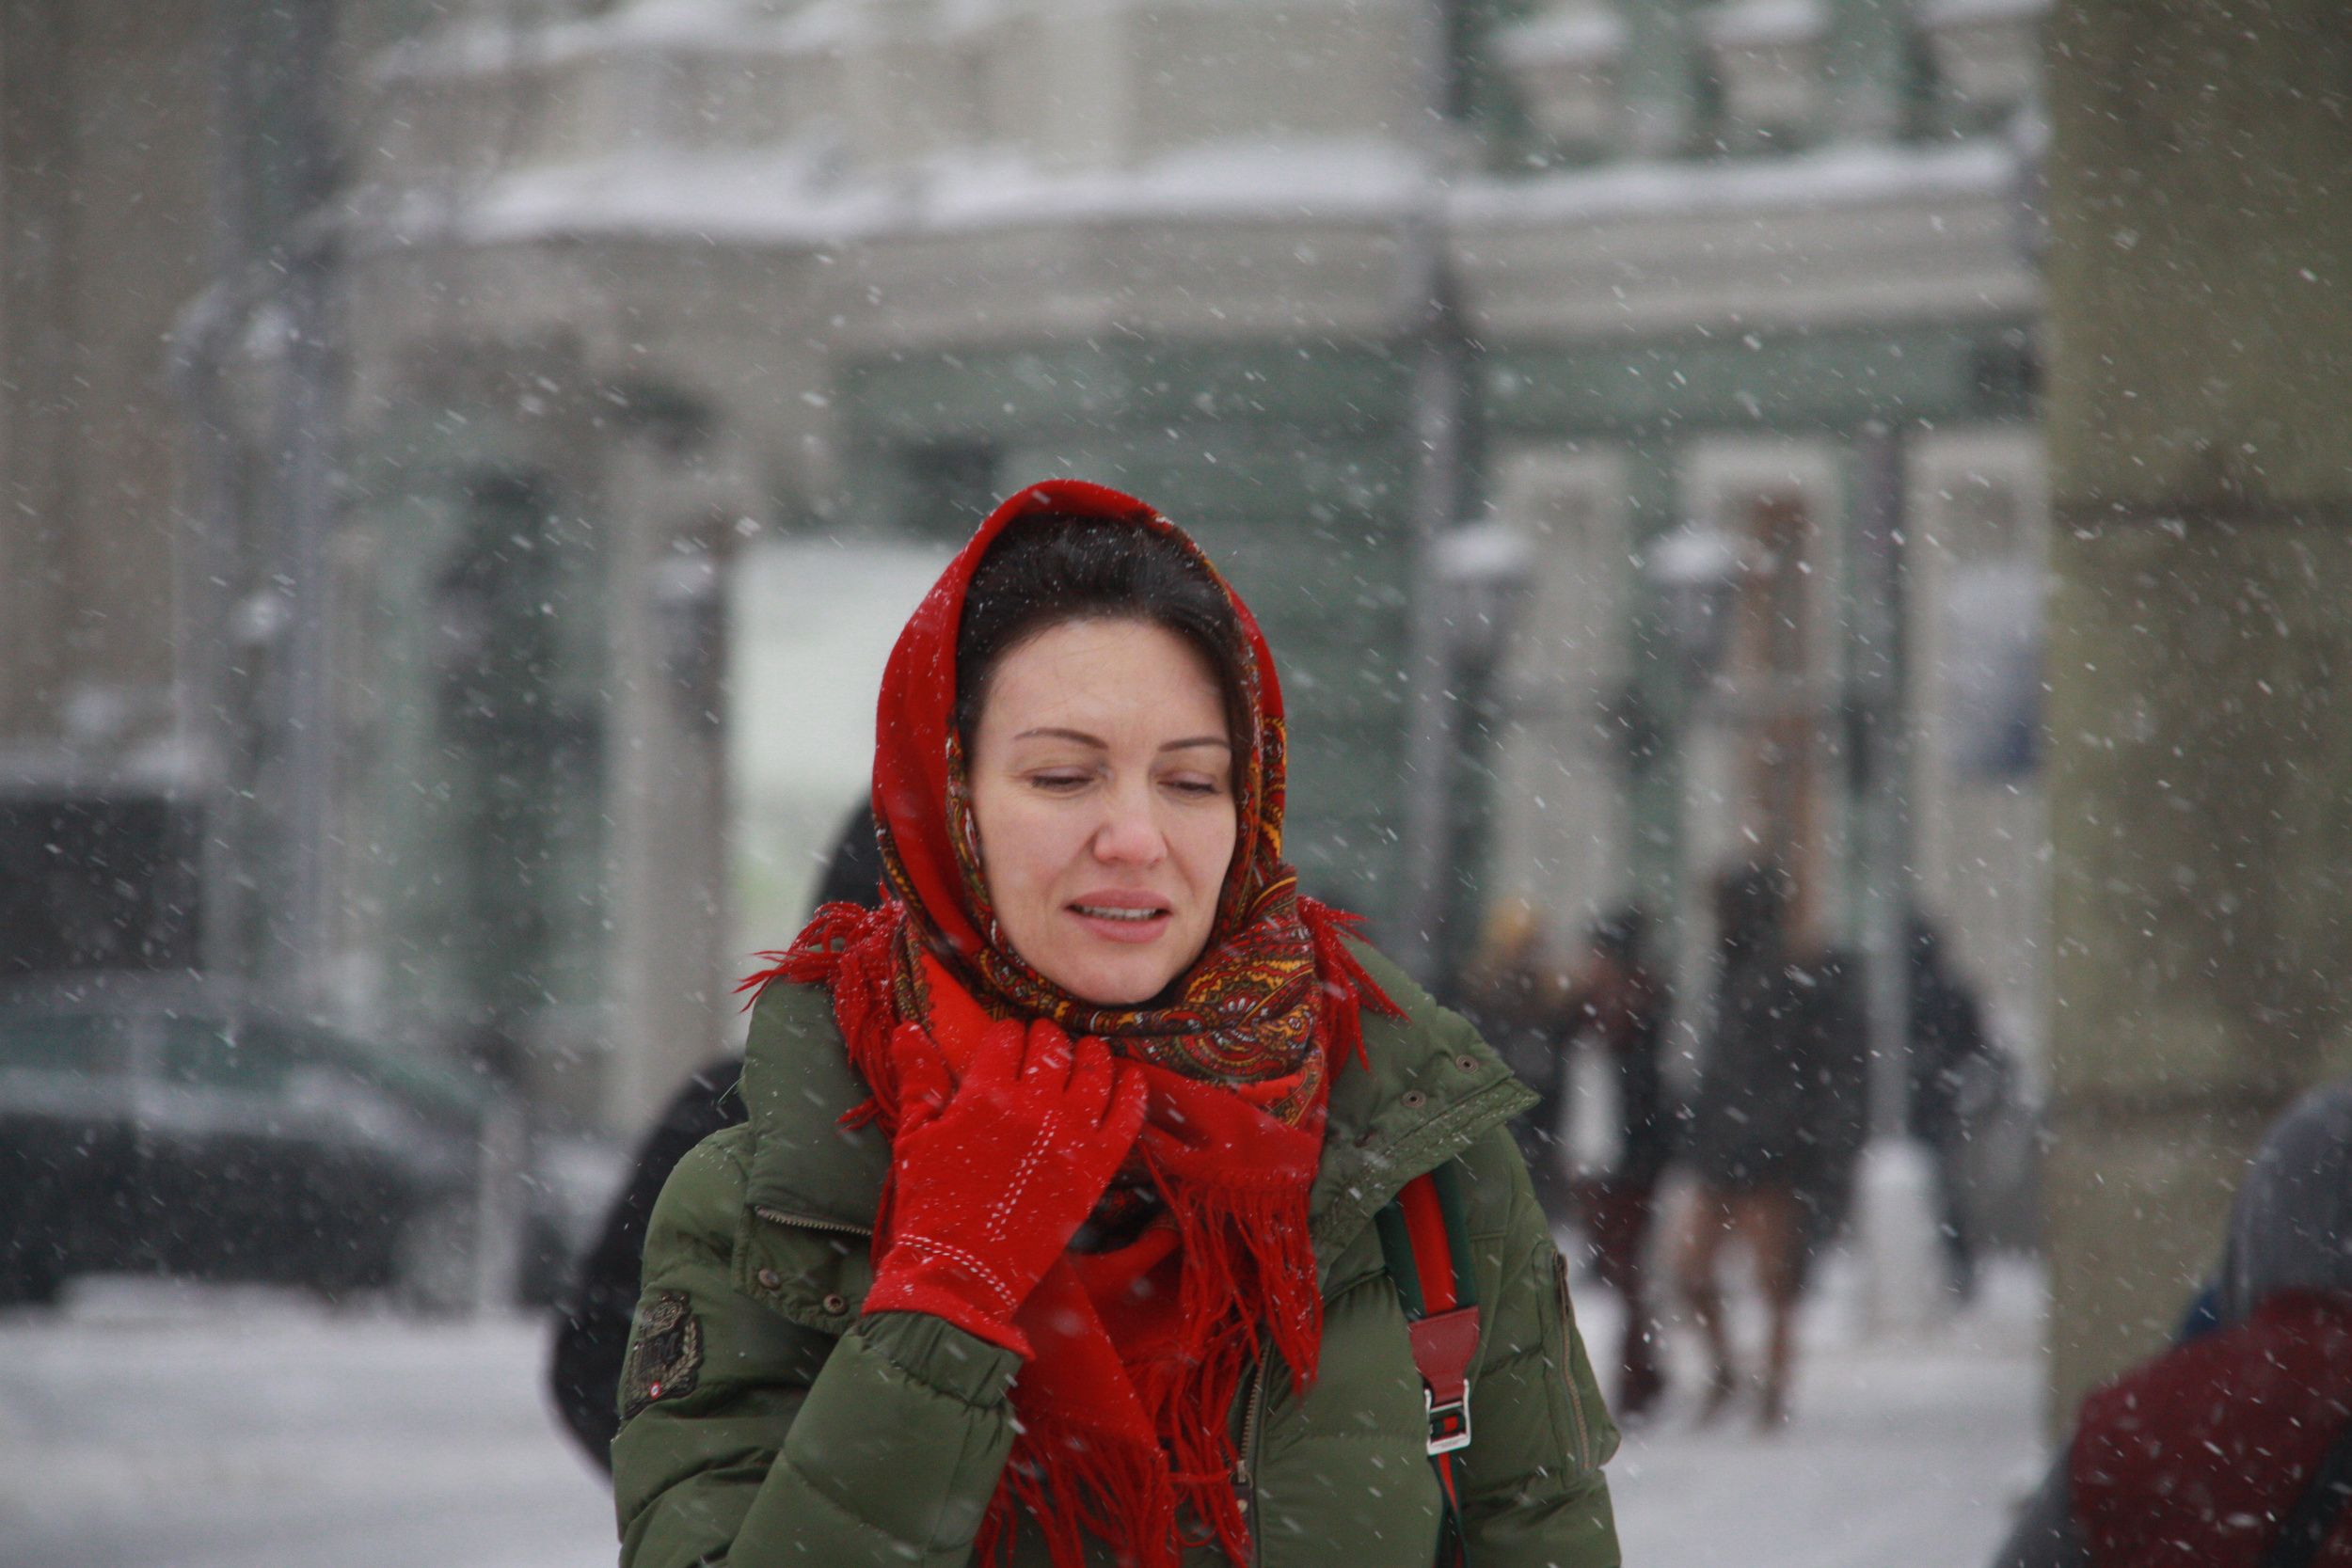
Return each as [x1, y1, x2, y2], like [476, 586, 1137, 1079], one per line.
[322, 0, 2042, 1132]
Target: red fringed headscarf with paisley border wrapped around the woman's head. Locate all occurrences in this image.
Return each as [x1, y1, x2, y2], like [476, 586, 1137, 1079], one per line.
[746, 480, 1397, 1568]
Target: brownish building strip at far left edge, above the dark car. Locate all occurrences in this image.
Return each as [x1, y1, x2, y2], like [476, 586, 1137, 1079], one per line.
[0, 0, 215, 971]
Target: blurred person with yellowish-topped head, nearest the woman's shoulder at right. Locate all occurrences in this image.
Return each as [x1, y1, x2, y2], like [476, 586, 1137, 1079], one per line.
[1456, 898, 1574, 1225]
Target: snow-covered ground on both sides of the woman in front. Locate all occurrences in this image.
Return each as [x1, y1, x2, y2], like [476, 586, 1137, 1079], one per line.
[0, 1270, 2040, 1568]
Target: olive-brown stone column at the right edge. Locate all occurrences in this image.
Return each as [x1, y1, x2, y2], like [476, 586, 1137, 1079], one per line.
[2049, 0, 2352, 1422]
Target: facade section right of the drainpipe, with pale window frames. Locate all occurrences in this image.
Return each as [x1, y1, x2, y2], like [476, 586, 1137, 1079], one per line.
[1458, 2, 2046, 1060]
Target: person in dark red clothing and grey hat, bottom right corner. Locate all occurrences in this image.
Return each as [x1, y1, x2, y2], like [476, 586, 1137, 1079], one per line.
[1993, 1079, 2352, 1568]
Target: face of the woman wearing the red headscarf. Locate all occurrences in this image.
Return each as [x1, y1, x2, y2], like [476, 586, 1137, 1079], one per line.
[967, 621, 1235, 1004]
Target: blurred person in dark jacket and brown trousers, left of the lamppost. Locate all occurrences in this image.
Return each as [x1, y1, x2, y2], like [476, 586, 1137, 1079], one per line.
[1675, 865, 1844, 1427]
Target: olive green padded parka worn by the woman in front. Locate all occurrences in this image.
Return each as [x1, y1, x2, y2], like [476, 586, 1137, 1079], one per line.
[612, 950, 1618, 1568]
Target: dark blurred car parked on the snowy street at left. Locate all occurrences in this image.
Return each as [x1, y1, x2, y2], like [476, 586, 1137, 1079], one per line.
[0, 975, 499, 1309]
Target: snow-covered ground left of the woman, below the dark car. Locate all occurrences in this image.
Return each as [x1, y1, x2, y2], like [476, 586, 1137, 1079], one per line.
[0, 1281, 616, 1568]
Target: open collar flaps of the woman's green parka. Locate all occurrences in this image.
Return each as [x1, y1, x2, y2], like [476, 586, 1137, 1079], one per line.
[743, 945, 1536, 1276]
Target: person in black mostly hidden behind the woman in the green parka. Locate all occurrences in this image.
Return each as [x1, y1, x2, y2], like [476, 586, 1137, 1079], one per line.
[548, 806, 882, 1472]
